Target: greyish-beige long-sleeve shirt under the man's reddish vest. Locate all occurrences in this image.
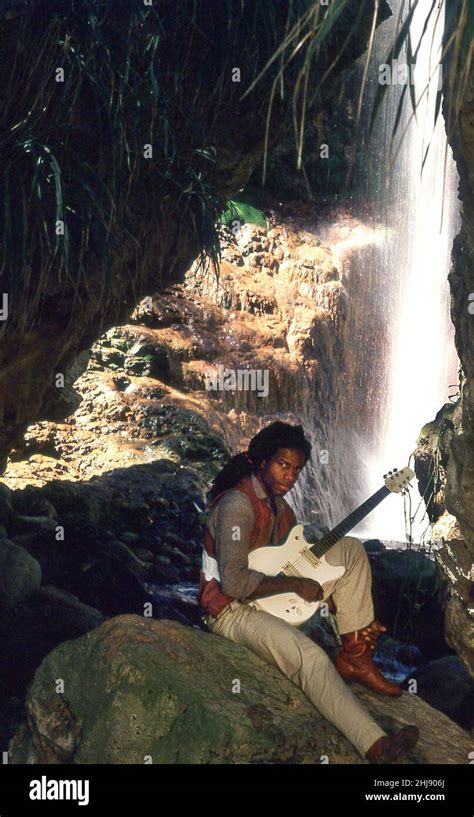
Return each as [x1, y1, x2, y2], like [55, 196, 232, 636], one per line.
[208, 475, 296, 601]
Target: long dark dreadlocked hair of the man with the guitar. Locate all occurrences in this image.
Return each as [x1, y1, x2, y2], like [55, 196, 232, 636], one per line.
[207, 420, 311, 502]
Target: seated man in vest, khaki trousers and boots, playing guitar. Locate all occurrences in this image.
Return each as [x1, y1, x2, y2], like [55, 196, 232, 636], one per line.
[199, 422, 419, 763]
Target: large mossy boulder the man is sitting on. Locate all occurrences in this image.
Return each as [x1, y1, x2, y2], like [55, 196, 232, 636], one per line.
[9, 615, 472, 764]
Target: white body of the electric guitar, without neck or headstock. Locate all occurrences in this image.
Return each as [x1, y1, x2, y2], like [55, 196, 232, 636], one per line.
[247, 525, 345, 624]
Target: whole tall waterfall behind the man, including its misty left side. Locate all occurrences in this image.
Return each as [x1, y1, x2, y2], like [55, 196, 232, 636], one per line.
[294, 0, 460, 542]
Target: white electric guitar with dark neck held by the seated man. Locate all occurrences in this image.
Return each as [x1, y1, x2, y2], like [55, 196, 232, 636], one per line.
[247, 468, 415, 624]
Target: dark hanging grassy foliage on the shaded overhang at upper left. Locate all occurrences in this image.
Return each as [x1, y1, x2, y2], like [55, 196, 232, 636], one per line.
[0, 0, 227, 328]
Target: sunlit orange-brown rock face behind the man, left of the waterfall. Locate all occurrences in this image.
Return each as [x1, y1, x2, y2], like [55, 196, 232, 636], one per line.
[1, 203, 356, 494]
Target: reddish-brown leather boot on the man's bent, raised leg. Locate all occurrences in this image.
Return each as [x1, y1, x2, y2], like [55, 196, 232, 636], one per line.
[335, 621, 402, 698]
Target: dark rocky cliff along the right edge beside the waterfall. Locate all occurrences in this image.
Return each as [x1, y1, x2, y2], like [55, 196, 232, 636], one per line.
[410, 2, 474, 674]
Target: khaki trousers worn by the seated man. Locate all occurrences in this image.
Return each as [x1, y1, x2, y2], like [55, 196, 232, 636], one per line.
[206, 536, 386, 760]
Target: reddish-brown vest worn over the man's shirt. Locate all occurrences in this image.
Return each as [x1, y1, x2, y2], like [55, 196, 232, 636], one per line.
[198, 477, 296, 616]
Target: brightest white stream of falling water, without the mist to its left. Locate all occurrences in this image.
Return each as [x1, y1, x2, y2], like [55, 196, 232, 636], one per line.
[354, 0, 459, 542]
